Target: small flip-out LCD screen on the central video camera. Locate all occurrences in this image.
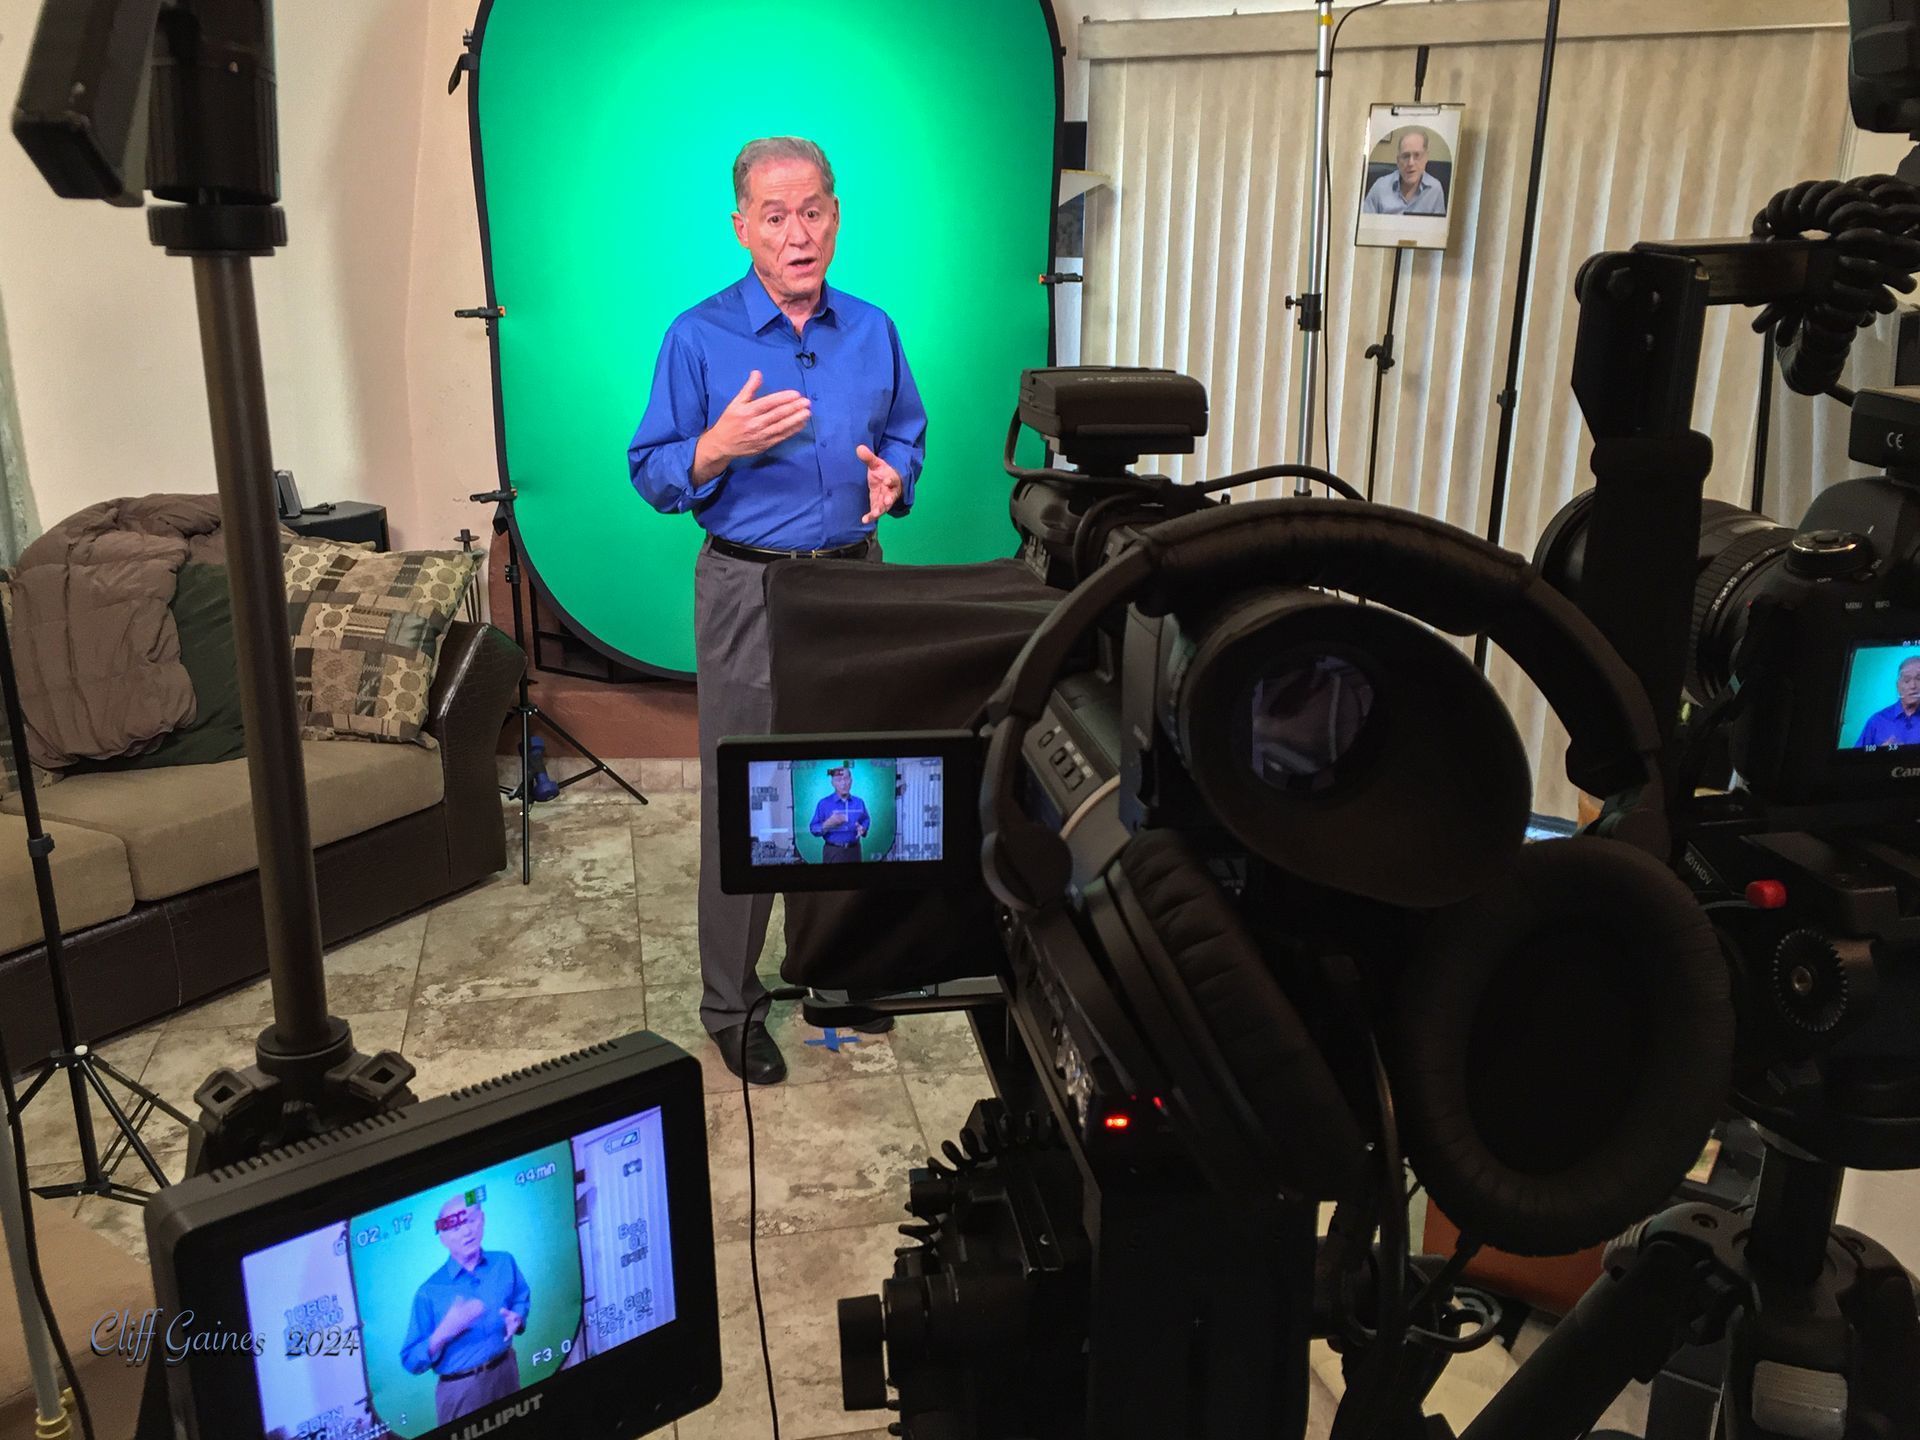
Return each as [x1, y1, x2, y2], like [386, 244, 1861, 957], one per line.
[718, 732, 979, 893]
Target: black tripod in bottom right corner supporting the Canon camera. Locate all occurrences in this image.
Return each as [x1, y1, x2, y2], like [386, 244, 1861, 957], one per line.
[1461, 1139, 1920, 1440]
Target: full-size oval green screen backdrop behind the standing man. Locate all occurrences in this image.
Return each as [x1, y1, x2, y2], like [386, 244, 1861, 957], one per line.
[470, 0, 1060, 674]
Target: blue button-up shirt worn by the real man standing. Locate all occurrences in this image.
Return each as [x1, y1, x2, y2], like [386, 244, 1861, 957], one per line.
[626, 271, 927, 549]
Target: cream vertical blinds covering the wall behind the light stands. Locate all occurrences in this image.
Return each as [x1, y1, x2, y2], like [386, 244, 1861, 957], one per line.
[1081, 22, 1847, 814]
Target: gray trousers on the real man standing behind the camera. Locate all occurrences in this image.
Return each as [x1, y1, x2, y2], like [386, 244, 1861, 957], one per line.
[693, 540, 879, 1033]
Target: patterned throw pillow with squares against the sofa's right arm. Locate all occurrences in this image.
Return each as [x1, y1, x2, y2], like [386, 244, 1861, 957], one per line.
[282, 540, 480, 743]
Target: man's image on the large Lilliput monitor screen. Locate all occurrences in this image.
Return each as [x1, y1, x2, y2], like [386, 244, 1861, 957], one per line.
[399, 1194, 530, 1425]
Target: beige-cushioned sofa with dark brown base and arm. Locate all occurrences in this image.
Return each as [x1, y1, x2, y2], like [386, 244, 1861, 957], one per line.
[0, 622, 526, 1066]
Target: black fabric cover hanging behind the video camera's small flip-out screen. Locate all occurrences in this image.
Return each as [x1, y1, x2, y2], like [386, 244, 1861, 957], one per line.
[766, 561, 1062, 993]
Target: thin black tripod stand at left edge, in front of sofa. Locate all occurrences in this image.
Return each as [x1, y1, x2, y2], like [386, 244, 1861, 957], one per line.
[0, 576, 190, 1204]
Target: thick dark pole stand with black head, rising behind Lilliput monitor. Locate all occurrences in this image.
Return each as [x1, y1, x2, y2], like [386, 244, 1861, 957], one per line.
[13, 0, 424, 1182]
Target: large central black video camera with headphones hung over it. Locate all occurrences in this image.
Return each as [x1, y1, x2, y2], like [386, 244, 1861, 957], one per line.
[718, 371, 1732, 1436]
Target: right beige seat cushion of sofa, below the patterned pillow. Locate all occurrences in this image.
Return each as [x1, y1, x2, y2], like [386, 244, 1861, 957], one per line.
[0, 739, 444, 900]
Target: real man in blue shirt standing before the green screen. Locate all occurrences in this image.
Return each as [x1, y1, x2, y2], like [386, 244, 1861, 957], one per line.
[628, 136, 927, 1085]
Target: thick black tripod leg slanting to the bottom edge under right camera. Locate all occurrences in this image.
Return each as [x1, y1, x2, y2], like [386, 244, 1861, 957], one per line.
[1461, 1242, 1699, 1440]
